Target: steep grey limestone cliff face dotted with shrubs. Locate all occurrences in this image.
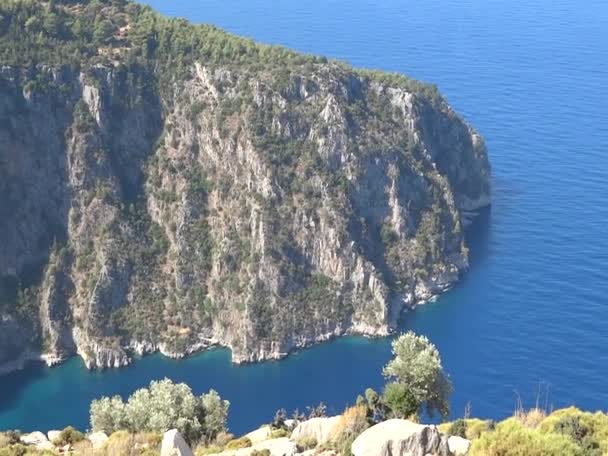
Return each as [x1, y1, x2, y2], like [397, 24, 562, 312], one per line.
[0, 55, 490, 367]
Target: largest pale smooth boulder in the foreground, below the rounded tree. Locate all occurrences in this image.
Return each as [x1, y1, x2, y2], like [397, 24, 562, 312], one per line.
[352, 419, 450, 456]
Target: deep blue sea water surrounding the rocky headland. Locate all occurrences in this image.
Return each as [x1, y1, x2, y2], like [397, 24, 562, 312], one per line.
[0, 0, 608, 433]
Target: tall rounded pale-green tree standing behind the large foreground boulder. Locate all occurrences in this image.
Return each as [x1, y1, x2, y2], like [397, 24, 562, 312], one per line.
[383, 331, 452, 418]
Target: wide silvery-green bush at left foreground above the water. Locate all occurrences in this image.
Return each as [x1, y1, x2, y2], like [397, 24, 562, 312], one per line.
[90, 379, 230, 442]
